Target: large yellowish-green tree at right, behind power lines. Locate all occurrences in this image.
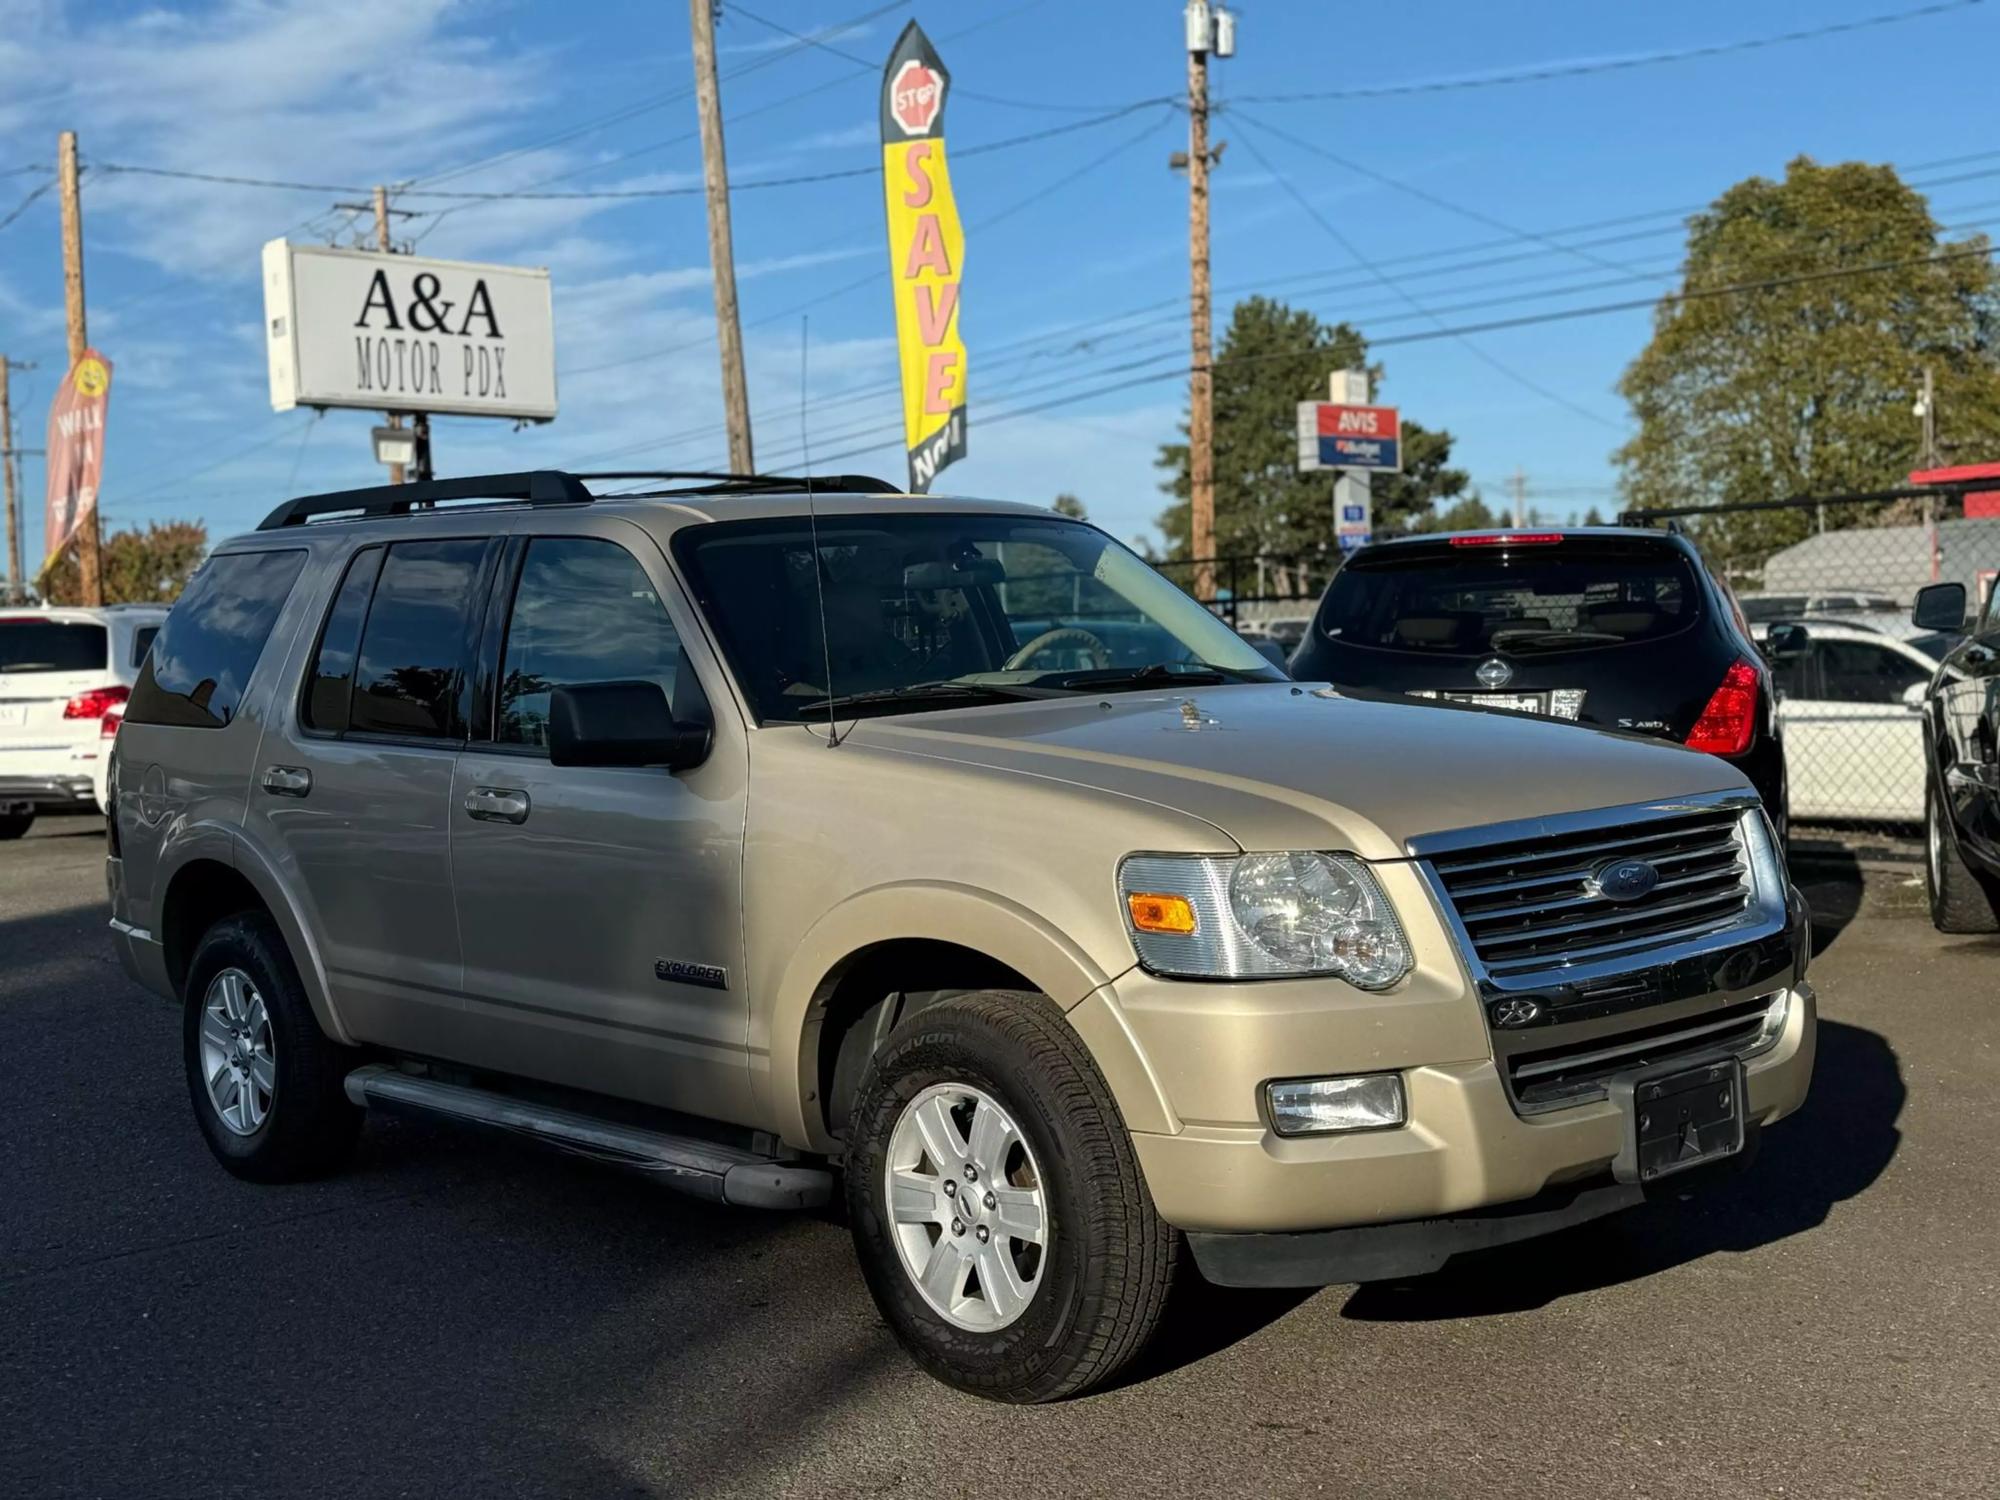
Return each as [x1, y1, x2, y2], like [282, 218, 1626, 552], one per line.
[1616, 156, 2000, 552]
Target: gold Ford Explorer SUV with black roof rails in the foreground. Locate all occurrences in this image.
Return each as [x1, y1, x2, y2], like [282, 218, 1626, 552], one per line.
[108, 472, 1814, 1402]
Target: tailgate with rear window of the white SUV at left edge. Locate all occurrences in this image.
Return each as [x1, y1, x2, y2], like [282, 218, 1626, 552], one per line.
[0, 614, 112, 794]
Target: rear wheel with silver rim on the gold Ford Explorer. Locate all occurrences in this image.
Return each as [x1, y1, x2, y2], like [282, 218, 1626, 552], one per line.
[182, 912, 362, 1182]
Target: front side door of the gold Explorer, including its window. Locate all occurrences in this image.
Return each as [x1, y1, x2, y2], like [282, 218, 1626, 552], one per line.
[452, 518, 750, 1120]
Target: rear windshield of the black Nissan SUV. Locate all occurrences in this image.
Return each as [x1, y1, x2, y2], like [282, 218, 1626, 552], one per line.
[1318, 540, 1700, 656]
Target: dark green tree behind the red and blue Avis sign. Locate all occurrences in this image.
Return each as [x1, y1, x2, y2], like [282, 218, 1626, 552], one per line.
[1156, 296, 1468, 560]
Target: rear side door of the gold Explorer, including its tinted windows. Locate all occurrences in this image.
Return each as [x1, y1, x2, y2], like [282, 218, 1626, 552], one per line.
[250, 534, 500, 1056]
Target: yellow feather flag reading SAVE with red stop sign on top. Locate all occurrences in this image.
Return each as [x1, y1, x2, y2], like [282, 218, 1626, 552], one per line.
[882, 20, 966, 494]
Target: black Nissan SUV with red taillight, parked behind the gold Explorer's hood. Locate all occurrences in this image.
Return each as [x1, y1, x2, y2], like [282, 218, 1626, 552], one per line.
[1292, 526, 1788, 844]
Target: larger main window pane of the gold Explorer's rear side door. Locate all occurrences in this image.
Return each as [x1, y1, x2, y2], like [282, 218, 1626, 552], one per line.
[348, 540, 486, 738]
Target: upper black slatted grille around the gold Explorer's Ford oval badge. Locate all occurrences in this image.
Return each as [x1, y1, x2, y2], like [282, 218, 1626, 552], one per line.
[1430, 806, 1752, 976]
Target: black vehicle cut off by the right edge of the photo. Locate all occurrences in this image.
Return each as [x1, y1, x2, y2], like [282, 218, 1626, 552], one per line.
[1910, 584, 2000, 932]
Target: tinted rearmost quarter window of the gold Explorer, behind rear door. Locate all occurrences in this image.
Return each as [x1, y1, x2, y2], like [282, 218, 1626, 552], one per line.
[126, 550, 306, 728]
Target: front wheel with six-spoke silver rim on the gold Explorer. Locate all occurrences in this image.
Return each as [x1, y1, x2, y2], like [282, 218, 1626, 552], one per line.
[846, 992, 1178, 1402]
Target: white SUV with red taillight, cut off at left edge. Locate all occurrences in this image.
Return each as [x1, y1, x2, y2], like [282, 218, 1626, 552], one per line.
[0, 604, 166, 840]
